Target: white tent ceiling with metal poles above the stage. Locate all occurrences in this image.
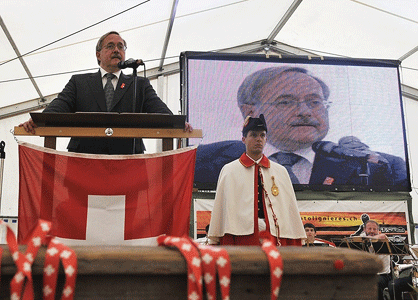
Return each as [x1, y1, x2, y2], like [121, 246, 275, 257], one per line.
[0, 0, 418, 119]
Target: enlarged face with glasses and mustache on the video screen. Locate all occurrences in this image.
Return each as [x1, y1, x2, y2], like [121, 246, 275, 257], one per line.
[254, 72, 329, 151]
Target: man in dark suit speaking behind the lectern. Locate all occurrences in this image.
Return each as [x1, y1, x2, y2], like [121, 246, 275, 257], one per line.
[19, 31, 193, 154]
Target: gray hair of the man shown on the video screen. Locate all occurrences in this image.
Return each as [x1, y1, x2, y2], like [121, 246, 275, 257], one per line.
[237, 66, 330, 107]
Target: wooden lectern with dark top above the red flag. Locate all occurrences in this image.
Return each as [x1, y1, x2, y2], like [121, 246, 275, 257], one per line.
[14, 112, 202, 151]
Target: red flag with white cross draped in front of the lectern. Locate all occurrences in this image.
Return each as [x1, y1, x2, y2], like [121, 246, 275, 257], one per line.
[18, 143, 196, 243]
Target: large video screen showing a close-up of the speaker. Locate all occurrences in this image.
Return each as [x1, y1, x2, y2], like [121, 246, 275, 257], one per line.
[180, 52, 410, 191]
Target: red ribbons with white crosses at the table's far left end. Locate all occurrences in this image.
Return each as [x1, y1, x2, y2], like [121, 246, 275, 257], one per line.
[0, 220, 77, 300]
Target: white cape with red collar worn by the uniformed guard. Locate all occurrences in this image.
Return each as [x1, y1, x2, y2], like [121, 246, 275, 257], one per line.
[208, 153, 306, 239]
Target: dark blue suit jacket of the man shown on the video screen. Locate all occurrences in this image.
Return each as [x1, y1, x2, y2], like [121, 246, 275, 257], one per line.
[194, 141, 410, 190]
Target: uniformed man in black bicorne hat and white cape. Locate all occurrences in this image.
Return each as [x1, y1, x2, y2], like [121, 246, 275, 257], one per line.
[208, 114, 306, 246]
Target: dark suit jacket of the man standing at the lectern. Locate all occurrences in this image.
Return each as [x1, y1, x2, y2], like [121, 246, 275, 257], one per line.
[44, 71, 172, 154]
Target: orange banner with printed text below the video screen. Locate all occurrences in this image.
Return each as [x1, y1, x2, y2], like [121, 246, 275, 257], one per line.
[194, 199, 410, 243]
